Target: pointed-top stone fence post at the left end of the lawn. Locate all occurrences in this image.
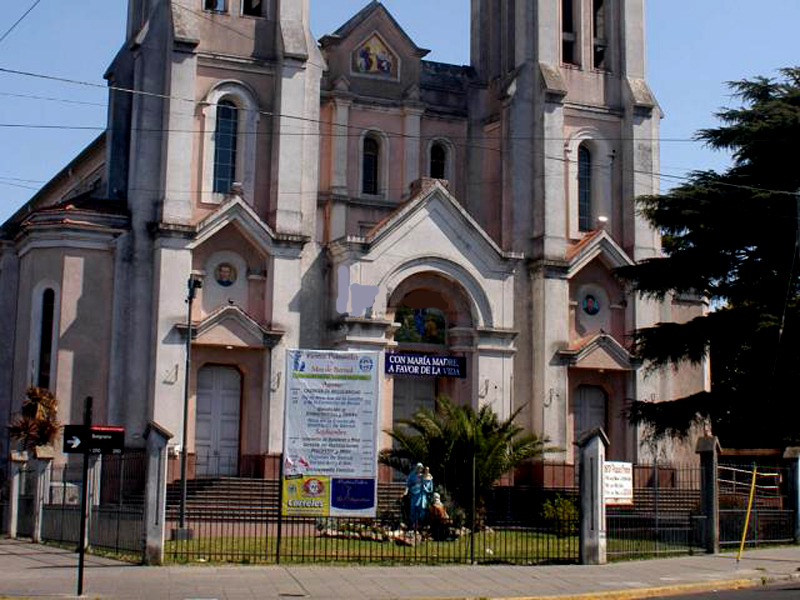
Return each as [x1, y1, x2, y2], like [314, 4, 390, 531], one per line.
[142, 421, 173, 565]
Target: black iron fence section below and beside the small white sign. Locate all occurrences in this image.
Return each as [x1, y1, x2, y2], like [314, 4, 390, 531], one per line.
[606, 465, 706, 560]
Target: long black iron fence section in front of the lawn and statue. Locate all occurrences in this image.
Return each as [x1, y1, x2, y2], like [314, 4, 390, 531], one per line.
[165, 461, 579, 564]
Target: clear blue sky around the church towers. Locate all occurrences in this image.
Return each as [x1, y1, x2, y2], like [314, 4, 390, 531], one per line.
[0, 0, 800, 222]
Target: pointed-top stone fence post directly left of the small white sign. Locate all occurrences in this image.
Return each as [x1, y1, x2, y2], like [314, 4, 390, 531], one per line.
[577, 427, 608, 565]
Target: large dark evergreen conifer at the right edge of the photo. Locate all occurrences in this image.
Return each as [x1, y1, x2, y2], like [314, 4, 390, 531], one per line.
[617, 67, 800, 447]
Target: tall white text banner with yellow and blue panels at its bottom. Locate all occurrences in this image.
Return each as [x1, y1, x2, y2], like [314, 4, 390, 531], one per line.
[281, 350, 380, 517]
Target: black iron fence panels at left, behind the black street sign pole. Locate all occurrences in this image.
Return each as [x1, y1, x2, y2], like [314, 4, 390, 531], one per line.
[42, 453, 146, 556]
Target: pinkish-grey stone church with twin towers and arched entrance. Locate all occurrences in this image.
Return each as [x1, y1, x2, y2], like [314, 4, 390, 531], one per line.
[0, 0, 709, 475]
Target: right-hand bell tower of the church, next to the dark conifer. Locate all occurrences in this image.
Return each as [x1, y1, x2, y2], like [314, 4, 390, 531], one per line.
[468, 0, 669, 460]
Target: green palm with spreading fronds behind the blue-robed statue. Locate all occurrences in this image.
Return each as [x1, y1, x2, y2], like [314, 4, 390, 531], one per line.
[379, 397, 552, 511]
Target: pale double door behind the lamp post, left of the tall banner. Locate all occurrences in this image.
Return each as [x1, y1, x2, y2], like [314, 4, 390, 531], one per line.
[194, 366, 242, 477]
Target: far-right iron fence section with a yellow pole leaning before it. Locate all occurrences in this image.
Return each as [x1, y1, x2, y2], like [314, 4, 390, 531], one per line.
[717, 464, 796, 547]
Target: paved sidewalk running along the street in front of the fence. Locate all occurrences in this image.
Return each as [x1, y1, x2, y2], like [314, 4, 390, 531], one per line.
[0, 540, 800, 600]
